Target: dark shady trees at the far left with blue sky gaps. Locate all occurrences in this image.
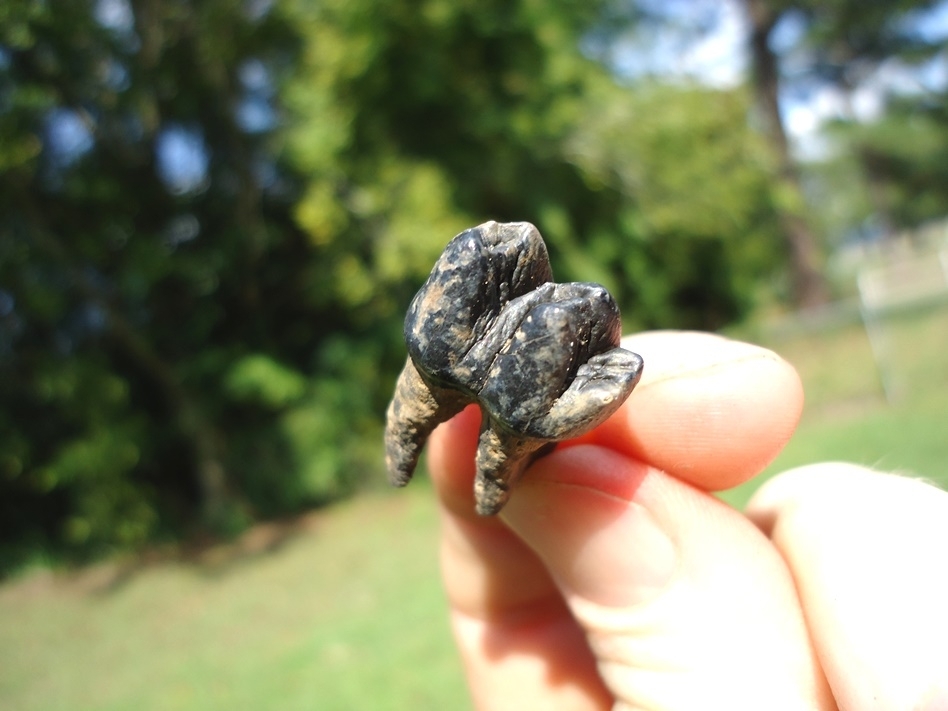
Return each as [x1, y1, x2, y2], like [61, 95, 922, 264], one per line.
[0, 0, 328, 560]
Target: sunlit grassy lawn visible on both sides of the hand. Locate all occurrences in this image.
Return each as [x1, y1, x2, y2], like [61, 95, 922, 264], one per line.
[0, 308, 948, 711]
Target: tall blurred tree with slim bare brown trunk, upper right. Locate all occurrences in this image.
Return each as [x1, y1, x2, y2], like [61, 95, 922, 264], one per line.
[742, 0, 945, 298]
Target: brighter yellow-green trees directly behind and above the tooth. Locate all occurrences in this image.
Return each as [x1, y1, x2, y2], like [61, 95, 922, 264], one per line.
[286, 0, 779, 328]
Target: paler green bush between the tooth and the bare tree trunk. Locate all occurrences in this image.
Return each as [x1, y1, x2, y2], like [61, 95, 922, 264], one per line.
[568, 82, 781, 329]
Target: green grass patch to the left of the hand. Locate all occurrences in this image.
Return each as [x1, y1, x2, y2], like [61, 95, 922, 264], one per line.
[0, 480, 469, 711]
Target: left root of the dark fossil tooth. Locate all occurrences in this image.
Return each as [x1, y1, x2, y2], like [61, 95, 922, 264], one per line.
[385, 358, 468, 486]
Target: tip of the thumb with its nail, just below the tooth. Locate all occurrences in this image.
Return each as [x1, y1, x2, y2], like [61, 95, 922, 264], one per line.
[503, 446, 678, 607]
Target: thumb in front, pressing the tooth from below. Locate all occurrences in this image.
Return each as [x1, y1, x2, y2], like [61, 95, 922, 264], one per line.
[502, 445, 835, 710]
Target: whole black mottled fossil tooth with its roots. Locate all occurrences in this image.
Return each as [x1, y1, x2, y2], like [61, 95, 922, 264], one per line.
[385, 222, 642, 515]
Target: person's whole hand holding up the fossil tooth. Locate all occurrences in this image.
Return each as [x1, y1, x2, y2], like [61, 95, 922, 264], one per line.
[429, 332, 948, 711]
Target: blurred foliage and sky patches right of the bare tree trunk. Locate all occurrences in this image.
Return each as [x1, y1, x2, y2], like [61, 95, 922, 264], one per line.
[756, 0, 948, 242]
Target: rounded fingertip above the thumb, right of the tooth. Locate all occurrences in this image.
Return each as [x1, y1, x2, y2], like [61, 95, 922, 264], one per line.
[590, 332, 803, 491]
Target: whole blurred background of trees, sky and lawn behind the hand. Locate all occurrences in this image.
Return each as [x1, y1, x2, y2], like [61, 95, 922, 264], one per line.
[0, 0, 948, 709]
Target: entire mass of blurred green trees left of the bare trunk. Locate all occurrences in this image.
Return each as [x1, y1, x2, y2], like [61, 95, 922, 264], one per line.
[0, 0, 780, 565]
